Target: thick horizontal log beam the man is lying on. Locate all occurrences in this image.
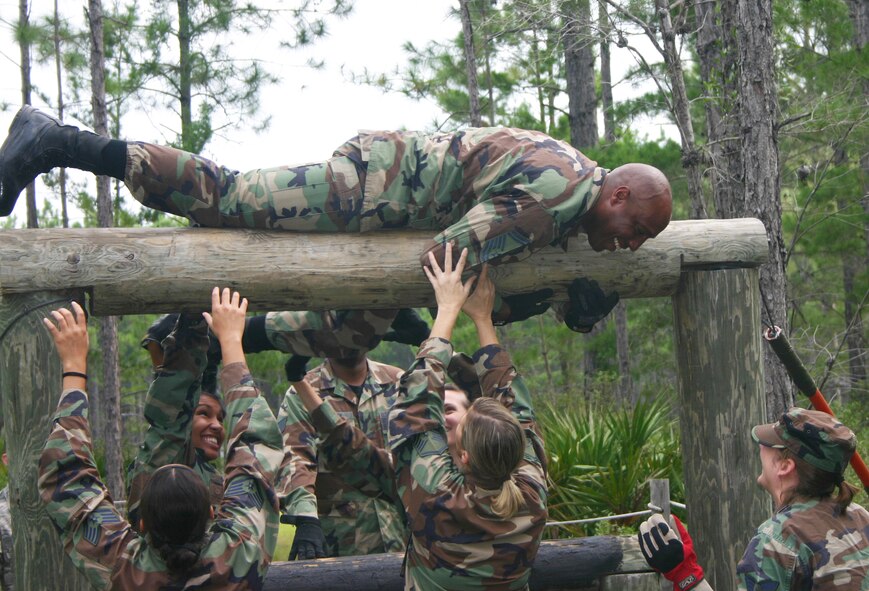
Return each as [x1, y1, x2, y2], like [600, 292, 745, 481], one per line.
[0, 219, 768, 315]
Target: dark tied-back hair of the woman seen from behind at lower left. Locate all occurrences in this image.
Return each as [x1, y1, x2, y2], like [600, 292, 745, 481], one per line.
[139, 464, 211, 574]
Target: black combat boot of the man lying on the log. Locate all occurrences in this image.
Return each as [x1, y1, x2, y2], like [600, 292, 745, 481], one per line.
[0, 105, 127, 216]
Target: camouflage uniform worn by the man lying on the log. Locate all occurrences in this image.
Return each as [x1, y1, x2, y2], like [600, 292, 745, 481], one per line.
[125, 127, 606, 266]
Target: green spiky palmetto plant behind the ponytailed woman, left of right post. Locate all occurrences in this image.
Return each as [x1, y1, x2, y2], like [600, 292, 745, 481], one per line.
[540, 400, 683, 535]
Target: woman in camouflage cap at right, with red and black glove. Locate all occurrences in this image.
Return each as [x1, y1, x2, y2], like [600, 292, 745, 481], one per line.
[639, 408, 869, 591]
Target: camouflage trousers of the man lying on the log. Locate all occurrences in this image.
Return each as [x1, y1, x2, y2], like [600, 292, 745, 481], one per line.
[124, 138, 386, 232]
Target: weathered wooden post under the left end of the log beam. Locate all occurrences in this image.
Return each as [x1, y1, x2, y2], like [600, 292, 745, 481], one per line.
[0, 291, 92, 591]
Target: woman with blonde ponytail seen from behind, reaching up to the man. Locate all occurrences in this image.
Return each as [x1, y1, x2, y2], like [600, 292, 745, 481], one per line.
[389, 245, 546, 591]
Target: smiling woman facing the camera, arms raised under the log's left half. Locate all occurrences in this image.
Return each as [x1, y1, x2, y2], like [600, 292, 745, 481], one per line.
[127, 314, 226, 528]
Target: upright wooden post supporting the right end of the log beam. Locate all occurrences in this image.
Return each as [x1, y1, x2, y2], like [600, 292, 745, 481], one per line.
[673, 269, 770, 589]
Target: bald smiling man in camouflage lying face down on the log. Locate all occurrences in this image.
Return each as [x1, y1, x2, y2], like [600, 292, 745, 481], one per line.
[0, 106, 672, 332]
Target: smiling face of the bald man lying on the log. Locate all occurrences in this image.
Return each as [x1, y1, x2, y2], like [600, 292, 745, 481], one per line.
[582, 187, 672, 252]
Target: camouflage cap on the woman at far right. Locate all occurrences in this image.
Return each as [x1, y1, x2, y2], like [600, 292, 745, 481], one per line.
[751, 407, 857, 474]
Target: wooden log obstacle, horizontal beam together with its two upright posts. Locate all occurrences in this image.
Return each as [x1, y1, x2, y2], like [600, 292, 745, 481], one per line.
[0, 219, 769, 590]
